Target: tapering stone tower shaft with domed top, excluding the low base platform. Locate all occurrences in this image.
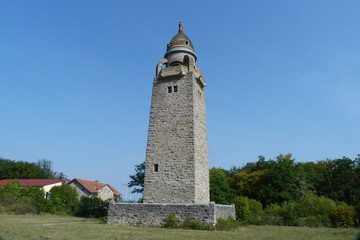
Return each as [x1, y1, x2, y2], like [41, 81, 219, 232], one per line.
[144, 22, 209, 204]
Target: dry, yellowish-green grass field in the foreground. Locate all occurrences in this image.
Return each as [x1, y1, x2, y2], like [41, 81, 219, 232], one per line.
[0, 215, 358, 240]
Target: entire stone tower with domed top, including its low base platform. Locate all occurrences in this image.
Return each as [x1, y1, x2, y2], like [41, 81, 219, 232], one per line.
[108, 22, 235, 226]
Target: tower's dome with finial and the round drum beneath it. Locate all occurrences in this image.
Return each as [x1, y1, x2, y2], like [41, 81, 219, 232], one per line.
[164, 22, 197, 66]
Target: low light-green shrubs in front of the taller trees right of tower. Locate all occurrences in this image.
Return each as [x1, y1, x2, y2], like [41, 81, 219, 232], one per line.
[233, 192, 358, 227]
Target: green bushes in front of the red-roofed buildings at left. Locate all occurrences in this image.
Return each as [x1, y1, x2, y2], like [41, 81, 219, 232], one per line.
[0, 180, 109, 218]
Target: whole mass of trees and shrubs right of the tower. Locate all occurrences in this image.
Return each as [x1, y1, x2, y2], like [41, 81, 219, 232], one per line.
[210, 154, 360, 227]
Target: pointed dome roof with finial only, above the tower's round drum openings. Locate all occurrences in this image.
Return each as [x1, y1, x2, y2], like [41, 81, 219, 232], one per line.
[165, 21, 196, 59]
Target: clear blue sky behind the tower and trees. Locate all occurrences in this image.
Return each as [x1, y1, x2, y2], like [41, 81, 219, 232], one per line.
[0, 0, 360, 198]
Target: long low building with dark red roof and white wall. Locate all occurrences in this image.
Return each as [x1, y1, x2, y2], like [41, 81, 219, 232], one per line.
[0, 179, 64, 198]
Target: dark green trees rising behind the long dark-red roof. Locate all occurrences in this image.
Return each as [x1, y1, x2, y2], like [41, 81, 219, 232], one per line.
[0, 158, 66, 180]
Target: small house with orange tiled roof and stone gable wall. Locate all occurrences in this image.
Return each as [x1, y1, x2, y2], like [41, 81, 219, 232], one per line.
[68, 178, 121, 200]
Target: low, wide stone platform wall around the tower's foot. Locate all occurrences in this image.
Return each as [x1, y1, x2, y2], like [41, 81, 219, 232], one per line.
[108, 202, 235, 226]
